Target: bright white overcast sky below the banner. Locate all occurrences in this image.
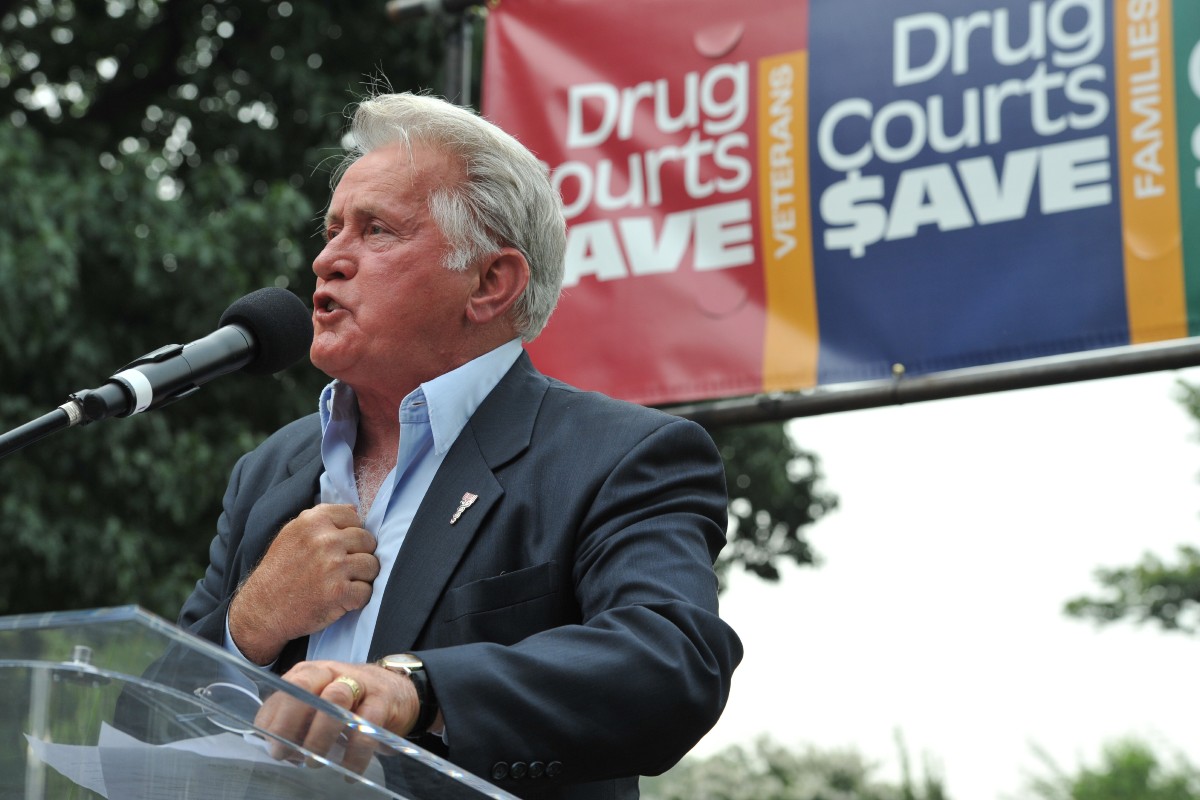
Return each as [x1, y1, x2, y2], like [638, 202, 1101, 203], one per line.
[695, 369, 1200, 800]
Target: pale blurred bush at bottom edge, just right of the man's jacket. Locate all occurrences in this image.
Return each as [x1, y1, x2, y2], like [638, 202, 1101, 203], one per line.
[641, 738, 948, 800]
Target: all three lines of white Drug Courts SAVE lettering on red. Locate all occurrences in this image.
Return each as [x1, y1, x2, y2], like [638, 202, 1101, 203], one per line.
[552, 61, 753, 285]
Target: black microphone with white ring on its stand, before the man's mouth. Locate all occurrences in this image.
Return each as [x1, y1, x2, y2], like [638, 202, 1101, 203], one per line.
[0, 287, 312, 457]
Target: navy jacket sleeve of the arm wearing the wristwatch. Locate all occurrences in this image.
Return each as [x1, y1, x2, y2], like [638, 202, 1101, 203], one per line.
[419, 409, 742, 790]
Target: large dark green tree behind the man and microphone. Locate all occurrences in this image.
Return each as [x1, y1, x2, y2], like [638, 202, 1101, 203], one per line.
[0, 0, 832, 618]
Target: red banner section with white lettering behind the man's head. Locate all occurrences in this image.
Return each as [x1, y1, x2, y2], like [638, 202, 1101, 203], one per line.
[484, 0, 815, 403]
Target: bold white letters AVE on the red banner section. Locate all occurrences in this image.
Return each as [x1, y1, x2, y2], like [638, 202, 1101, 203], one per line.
[563, 200, 755, 287]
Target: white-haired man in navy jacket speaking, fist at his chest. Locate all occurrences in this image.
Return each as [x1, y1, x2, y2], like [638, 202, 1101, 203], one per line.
[180, 94, 742, 799]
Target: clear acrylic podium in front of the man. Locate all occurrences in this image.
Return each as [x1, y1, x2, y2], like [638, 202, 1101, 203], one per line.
[0, 606, 515, 800]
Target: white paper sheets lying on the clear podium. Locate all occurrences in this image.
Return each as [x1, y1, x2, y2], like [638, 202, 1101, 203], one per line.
[25, 723, 383, 800]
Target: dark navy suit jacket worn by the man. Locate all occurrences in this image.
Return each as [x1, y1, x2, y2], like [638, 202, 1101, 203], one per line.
[180, 354, 742, 798]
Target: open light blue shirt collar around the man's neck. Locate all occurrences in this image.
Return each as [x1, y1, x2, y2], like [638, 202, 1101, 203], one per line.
[320, 338, 521, 455]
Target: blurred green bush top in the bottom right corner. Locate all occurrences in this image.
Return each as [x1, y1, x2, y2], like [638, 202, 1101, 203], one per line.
[1031, 739, 1200, 800]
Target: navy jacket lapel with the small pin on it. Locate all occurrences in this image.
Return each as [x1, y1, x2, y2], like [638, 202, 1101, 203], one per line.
[370, 353, 548, 661]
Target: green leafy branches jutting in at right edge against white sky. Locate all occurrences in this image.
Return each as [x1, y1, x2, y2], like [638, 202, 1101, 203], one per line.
[1066, 383, 1200, 633]
